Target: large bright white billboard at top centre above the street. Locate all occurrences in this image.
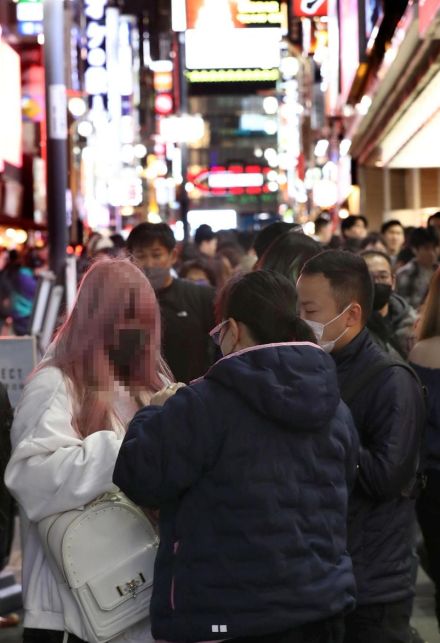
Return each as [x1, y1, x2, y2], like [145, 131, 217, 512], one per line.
[186, 0, 282, 83]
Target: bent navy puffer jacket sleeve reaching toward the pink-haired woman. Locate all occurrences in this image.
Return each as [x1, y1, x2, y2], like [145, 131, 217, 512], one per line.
[113, 387, 218, 507]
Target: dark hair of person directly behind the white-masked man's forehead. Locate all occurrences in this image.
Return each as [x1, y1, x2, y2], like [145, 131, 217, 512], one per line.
[257, 232, 321, 284]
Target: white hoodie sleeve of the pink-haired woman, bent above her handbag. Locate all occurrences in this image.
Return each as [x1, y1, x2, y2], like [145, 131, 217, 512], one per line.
[5, 368, 121, 522]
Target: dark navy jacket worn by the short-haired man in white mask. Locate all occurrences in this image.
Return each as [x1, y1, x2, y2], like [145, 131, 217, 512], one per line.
[333, 330, 425, 605]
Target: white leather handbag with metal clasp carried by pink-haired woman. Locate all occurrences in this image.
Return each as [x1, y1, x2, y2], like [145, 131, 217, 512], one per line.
[38, 492, 159, 643]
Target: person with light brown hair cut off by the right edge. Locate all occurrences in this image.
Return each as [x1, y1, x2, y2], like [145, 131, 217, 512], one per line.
[410, 269, 440, 627]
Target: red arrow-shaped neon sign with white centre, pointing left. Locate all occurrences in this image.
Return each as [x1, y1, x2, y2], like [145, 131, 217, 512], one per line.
[188, 164, 273, 196]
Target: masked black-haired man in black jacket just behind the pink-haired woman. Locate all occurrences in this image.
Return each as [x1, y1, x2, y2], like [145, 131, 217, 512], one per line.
[127, 223, 215, 383]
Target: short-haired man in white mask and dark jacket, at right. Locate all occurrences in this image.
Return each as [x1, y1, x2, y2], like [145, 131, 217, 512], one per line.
[297, 251, 425, 643]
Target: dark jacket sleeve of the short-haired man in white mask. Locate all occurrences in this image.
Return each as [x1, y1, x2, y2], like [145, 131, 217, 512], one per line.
[358, 367, 425, 500]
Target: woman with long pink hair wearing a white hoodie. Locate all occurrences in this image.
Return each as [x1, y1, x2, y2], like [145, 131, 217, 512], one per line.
[5, 259, 171, 643]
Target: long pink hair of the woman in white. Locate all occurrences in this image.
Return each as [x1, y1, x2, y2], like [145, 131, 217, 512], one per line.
[40, 259, 172, 437]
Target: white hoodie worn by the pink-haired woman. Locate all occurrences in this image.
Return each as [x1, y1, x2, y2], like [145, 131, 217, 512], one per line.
[5, 366, 153, 643]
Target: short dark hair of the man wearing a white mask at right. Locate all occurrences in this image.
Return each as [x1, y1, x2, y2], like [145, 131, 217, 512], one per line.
[302, 250, 374, 324]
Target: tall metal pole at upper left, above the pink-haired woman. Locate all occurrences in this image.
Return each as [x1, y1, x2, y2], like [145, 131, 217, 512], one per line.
[43, 0, 67, 278]
